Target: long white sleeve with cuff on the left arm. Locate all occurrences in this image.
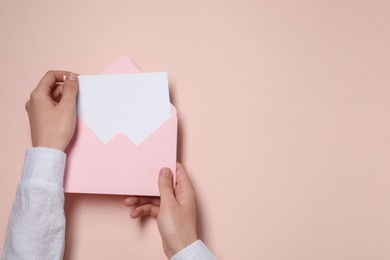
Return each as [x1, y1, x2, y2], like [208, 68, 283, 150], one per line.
[2, 147, 66, 260]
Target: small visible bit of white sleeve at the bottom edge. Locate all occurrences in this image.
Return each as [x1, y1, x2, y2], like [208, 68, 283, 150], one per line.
[171, 240, 217, 260]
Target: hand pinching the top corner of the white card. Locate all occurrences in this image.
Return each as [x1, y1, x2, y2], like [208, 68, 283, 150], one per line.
[26, 71, 78, 151]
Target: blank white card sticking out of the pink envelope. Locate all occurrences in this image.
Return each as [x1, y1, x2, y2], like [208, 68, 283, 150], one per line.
[77, 72, 171, 145]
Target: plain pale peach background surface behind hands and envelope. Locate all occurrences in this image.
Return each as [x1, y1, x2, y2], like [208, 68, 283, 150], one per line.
[0, 0, 390, 260]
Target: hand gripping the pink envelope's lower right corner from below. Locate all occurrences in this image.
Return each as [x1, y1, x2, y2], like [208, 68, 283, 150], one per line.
[124, 163, 198, 258]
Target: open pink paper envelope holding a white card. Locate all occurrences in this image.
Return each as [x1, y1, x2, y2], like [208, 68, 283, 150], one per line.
[64, 57, 177, 196]
